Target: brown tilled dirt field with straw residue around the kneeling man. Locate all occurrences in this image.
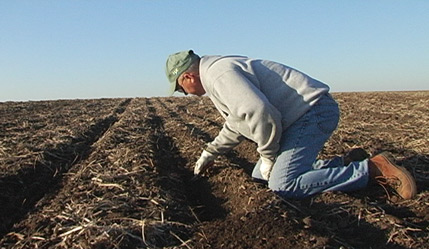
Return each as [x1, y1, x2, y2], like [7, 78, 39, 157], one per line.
[0, 91, 429, 248]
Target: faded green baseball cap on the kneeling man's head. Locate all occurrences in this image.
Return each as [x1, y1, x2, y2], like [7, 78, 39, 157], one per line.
[165, 50, 200, 95]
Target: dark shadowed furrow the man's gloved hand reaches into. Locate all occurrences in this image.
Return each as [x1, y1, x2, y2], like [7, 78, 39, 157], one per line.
[140, 99, 226, 247]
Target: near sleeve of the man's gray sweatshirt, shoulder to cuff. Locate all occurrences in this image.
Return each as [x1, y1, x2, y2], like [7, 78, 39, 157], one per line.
[207, 70, 282, 160]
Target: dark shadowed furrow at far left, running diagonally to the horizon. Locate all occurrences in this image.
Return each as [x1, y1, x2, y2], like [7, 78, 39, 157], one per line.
[0, 99, 131, 237]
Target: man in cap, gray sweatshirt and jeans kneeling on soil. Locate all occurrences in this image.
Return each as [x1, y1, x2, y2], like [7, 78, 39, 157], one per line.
[166, 50, 416, 199]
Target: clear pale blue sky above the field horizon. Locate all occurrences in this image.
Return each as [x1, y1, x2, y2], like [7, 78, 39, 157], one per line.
[0, 0, 429, 101]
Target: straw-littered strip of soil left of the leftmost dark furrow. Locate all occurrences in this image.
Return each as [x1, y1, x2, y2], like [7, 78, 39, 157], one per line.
[0, 99, 125, 175]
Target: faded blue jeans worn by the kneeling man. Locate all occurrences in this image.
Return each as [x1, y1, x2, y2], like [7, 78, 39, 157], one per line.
[252, 94, 369, 199]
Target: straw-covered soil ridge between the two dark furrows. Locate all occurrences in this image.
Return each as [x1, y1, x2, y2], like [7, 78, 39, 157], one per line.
[0, 99, 197, 248]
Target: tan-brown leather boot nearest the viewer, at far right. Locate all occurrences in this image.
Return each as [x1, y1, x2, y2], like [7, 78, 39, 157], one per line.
[368, 152, 417, 199]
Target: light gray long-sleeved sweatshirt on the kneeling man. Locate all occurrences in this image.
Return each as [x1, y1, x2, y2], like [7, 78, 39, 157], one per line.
[200, 56, 329, 160]
